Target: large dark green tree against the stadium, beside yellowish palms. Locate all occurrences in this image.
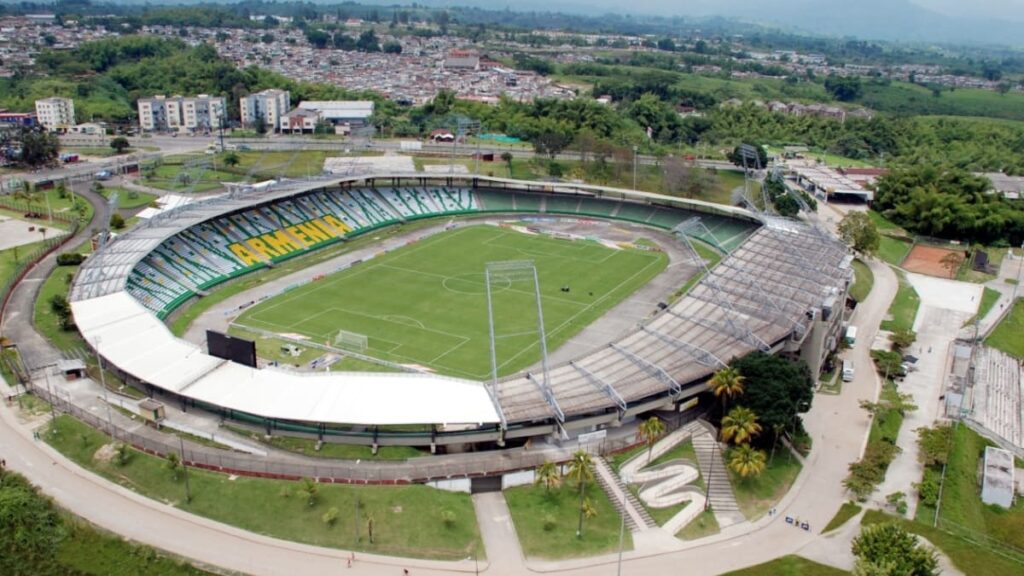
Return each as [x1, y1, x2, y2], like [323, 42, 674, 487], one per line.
[732, 352, 814, 440]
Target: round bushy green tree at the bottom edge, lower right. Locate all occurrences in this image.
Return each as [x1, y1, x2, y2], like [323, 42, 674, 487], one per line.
[852, 522, 939, 576]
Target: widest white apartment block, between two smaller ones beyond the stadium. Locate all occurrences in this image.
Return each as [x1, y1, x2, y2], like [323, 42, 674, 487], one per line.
[138, 94, 227, 132]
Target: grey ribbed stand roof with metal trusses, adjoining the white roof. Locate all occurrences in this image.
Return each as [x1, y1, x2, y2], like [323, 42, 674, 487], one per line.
[496, 225, 850, 421]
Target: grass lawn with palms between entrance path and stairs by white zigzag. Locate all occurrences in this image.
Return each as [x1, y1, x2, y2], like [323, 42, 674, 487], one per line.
[505, 482, 633, 559]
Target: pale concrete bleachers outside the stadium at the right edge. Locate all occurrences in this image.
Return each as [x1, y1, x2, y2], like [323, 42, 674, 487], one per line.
[971, 346, 1024, 447]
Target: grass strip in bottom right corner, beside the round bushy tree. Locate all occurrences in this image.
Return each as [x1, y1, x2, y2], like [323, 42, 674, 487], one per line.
[860, 510, 1024, 576]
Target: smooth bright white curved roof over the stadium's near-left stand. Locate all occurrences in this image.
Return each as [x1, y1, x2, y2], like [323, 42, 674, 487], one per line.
[72, 292, 500, 425]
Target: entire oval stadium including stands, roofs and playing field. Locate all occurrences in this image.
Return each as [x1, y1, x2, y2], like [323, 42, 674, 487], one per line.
[71, 173, 852, 459]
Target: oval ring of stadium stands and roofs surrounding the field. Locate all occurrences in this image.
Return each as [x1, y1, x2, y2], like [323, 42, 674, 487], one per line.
[71, 174, 852, 448]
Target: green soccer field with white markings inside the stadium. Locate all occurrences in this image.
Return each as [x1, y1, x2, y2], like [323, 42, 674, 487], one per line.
[237, 225, 668, 379]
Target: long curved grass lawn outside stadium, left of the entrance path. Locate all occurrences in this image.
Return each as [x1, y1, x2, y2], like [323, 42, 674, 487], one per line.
[45, 416, 483, 560]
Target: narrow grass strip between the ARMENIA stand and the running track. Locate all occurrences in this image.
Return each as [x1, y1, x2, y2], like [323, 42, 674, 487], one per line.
[170, 218, 448, 336]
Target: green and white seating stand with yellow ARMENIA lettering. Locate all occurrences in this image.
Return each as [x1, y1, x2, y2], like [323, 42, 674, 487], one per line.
[126, 187, 754, 318]
